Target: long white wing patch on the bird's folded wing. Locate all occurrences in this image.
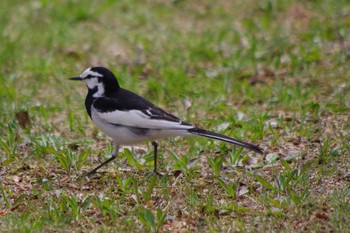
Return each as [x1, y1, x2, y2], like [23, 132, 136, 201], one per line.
[91, 107, 194, 129]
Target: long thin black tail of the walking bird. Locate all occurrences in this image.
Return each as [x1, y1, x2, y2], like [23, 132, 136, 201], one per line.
[188, 128, 264, 154]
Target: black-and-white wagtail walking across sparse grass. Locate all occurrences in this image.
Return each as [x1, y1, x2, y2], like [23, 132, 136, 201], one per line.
[69, 67, 263, 176]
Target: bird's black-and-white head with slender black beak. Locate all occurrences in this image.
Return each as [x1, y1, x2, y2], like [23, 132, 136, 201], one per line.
[69, 67, 120, 98]
